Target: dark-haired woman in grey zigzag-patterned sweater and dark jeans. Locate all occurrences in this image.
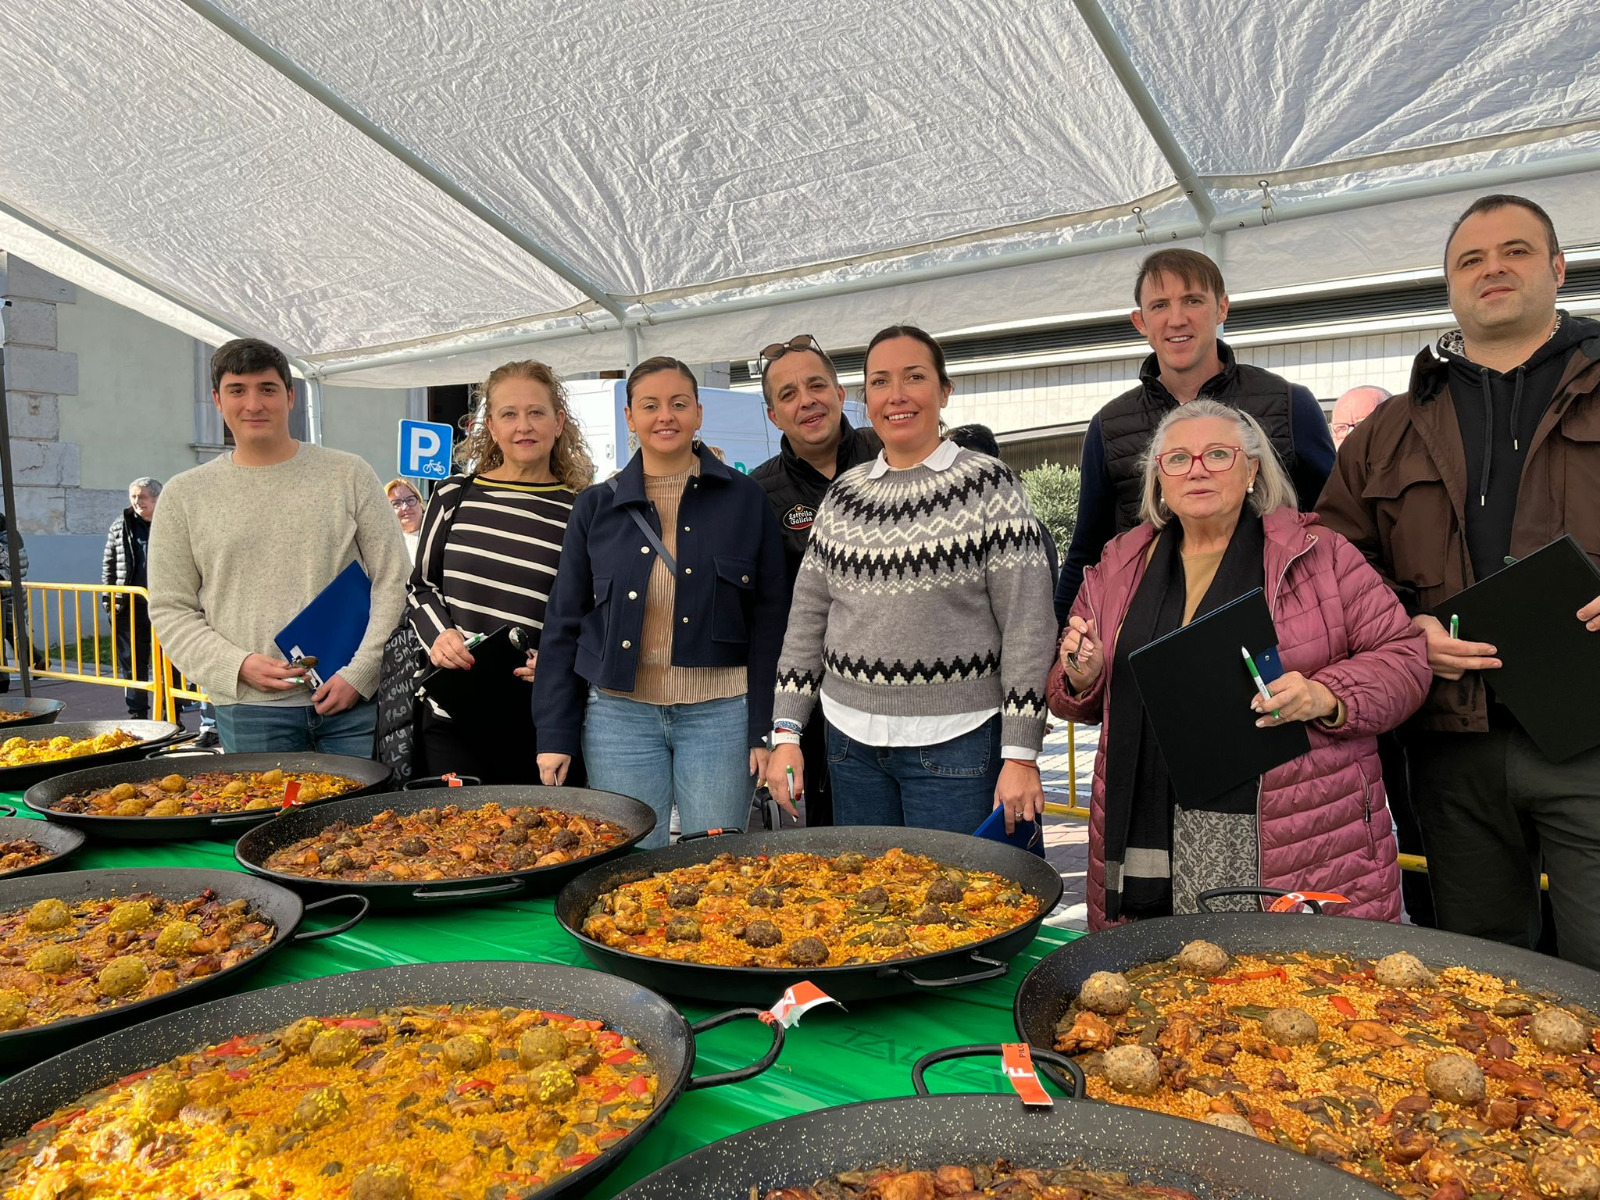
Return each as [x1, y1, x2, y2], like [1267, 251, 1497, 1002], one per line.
[768, 325, 1056, 834]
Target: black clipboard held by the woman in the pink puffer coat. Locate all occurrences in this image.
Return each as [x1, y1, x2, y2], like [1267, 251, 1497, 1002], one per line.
[1128, 587, 1310, 806]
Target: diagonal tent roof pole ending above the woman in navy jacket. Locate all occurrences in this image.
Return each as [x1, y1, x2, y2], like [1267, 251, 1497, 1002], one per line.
[182, 0, 627, 323]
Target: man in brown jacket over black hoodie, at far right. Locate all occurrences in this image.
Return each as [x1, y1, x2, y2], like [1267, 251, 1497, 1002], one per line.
[1317, 195, 1600, 968]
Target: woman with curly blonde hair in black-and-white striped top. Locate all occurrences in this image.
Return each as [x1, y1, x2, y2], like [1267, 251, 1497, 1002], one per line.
[406, 360, 594, 784]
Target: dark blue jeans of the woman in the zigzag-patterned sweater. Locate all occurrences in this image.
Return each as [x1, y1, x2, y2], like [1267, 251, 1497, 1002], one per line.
[827, 714, 1000, 834]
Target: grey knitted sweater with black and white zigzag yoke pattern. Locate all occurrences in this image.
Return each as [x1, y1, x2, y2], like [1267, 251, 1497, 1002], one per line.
[773, 450, 1056, 749]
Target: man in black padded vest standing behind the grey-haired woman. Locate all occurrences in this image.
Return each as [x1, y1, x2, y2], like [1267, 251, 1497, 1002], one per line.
[1056, 250, 1333, 626]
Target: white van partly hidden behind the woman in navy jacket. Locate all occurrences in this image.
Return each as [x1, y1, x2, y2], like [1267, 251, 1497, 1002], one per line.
[566, 379, 866, 480]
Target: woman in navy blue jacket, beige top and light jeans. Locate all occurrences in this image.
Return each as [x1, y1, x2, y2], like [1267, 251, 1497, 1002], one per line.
[533, 358, 787, 846]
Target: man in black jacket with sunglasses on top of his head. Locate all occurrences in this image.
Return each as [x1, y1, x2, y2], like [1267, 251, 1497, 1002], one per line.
[750, 333, 883, 826]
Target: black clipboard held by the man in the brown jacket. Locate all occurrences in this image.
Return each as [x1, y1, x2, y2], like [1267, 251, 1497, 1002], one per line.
[1434, 534, 1600, 763]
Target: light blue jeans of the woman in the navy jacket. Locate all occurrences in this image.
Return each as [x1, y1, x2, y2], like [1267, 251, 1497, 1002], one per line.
[584, 688, 755, 850]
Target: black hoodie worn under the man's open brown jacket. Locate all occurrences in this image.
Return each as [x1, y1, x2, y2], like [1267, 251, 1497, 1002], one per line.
[1438, 312, 1600, 579]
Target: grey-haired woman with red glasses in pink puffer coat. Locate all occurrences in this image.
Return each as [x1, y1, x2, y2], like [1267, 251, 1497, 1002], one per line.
[1048, 400, 1430, 930]
